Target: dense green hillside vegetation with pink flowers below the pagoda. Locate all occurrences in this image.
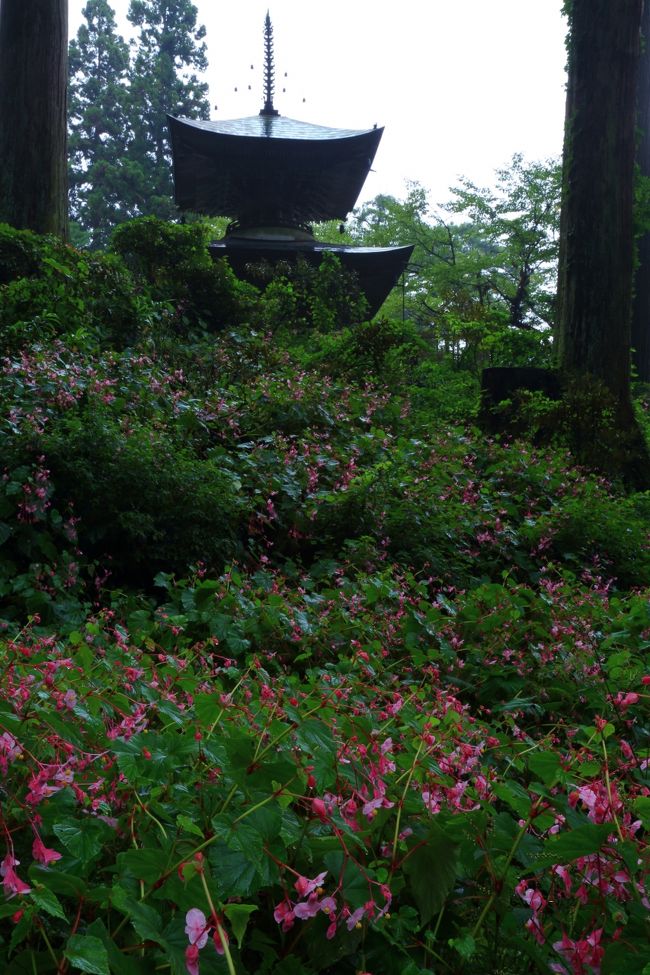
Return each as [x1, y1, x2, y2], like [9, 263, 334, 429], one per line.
[0, 220, 650, 975]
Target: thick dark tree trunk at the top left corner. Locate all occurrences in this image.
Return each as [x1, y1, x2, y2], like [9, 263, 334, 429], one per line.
[0, 0, 68, 238]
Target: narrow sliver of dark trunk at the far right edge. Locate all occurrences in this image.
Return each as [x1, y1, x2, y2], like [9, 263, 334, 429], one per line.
[632, 0, 650, 383]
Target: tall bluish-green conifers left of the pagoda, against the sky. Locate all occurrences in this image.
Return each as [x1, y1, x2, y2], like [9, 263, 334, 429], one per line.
[69, 0, 209, 240]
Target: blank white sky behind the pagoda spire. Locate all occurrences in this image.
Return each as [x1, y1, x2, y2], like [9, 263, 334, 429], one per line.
[70, 0, 566, 204]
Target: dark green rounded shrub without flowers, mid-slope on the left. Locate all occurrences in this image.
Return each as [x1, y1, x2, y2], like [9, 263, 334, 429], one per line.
[39, 409, 240, 587]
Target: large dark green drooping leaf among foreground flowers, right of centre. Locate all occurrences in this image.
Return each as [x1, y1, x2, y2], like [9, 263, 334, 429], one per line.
[404, 824, 458, 925]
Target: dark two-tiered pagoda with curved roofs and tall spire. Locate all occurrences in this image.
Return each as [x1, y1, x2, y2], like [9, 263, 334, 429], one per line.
[168, 13, 413, 317]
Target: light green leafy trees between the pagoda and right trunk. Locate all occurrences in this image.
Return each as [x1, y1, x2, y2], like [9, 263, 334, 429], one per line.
[351, 155, 560, 373]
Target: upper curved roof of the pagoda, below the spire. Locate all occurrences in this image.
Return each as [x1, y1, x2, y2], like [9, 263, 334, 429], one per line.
[168, 114, 383, 227]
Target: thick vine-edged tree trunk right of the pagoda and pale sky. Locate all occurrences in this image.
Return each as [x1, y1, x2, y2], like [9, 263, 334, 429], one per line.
[558, 0, 643, 408]
